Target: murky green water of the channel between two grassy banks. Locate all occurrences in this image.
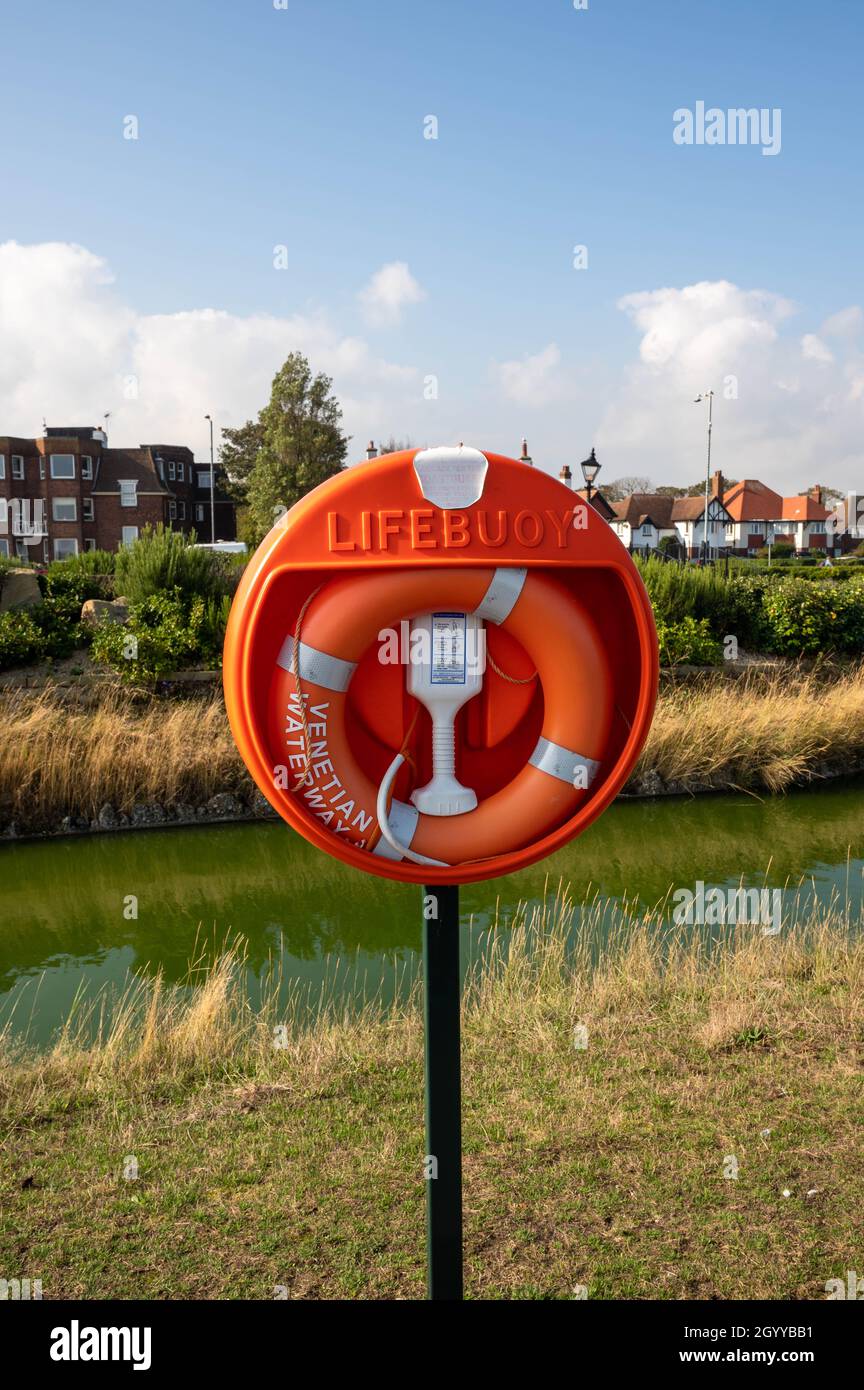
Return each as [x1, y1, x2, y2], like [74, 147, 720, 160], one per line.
[0, 784, 864, 1041]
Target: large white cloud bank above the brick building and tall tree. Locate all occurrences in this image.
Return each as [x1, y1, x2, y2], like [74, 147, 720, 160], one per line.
[0, 242, 421, 457]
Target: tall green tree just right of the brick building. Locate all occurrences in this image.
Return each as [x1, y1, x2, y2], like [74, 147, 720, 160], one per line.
[235, 352, 349, 539]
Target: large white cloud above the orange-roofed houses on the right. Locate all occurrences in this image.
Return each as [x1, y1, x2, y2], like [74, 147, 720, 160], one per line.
[596, 281, 864, 493]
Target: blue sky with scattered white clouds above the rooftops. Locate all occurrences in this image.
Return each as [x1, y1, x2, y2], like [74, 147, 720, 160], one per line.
[0, 0, 864, 491]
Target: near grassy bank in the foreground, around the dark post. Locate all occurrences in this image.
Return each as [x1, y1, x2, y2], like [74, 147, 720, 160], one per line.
[0, 898, 864, 1300]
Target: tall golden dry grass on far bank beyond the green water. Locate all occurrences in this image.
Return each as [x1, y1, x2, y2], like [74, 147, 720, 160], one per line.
[0, 666, 864, 834]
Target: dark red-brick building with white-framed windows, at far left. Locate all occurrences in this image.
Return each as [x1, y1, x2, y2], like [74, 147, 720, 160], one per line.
[0, 425, 236, 563]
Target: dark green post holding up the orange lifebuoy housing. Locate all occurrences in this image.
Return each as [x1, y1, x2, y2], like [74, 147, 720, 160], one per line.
[424, 884, 463, 1301]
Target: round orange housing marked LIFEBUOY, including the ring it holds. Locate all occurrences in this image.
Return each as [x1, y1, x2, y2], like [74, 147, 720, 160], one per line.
[224, 446, 658, 884]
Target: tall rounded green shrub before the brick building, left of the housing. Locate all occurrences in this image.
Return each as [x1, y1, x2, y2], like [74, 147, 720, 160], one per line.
[115, 525, 226, 603]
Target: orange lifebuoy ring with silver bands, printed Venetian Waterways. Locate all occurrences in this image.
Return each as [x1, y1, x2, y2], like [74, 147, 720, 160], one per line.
[267, 566, 614, 865]
